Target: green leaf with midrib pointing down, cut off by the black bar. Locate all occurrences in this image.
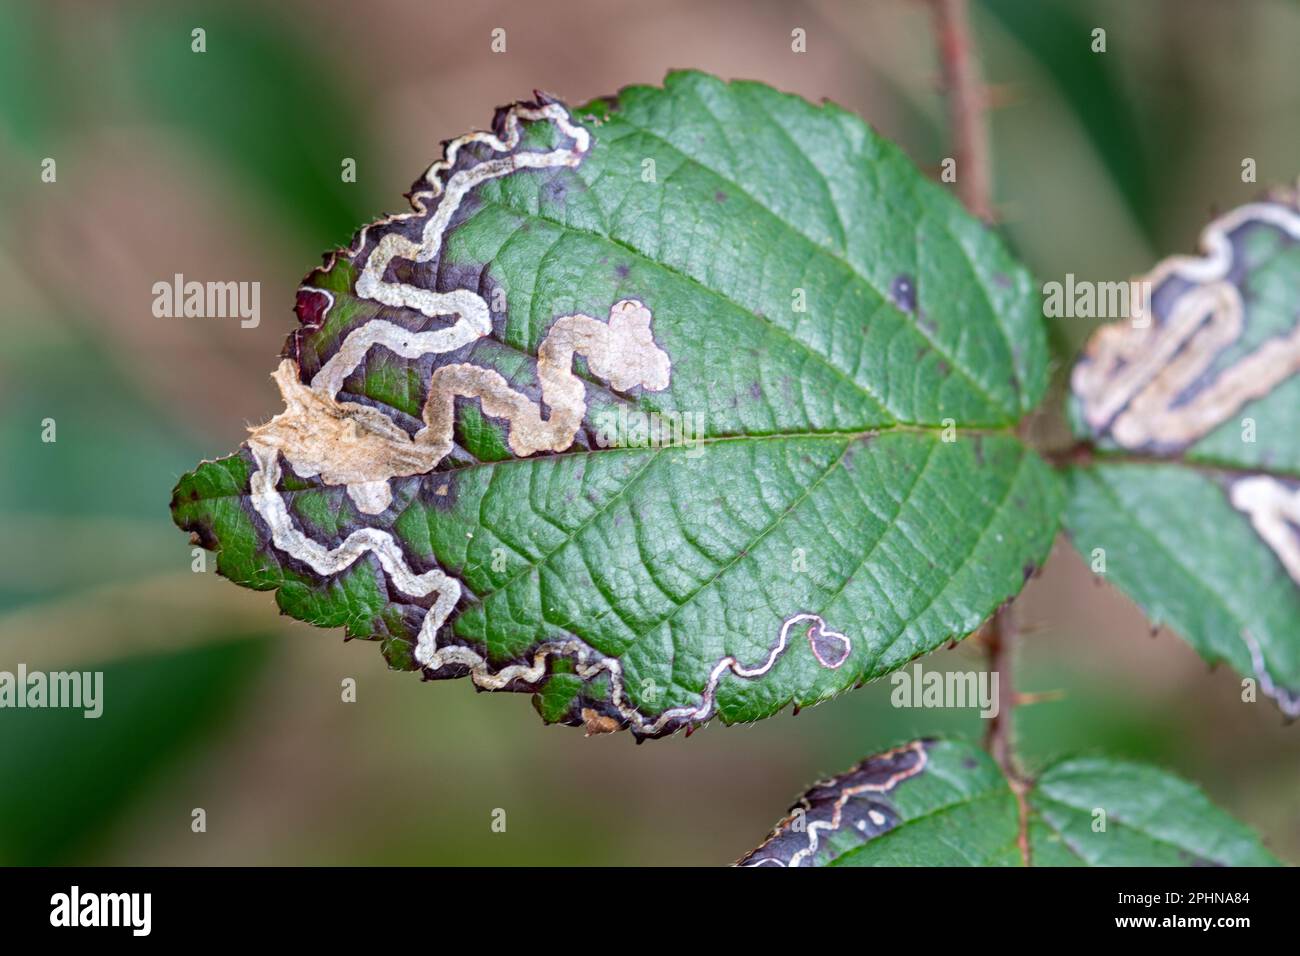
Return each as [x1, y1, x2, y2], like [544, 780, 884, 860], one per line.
[740, 740, 1278, 866]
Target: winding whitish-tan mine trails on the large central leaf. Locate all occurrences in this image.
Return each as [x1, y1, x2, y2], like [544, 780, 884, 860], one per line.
[237, 101, 853, 735]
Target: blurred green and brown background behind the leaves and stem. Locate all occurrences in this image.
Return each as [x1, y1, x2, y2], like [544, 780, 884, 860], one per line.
[0, 0, 1300, 864]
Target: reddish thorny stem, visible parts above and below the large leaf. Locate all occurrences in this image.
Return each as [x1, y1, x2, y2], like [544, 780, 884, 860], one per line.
[931, 0, 1030, 866]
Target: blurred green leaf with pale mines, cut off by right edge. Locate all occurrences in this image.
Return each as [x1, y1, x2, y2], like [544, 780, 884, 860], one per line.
[1066, 196, 1300, 717]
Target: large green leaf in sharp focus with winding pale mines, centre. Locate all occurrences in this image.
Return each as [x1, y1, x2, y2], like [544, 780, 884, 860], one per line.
[173, 73, 1061, 736]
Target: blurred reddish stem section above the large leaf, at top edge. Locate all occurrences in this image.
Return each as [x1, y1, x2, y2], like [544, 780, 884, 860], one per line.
[932, 0, 993, 222]
